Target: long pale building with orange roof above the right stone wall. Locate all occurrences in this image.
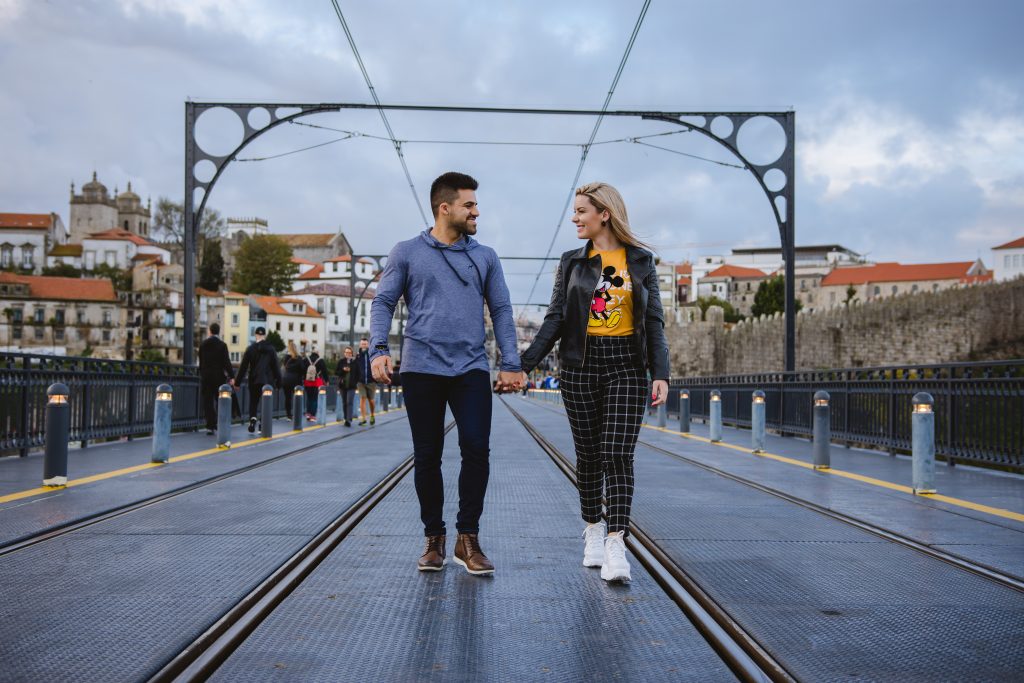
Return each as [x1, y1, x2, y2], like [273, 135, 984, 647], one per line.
[819, 259, 992, 308]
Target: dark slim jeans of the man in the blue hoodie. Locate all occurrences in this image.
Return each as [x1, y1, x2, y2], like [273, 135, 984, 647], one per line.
[401, 370, 490, 536]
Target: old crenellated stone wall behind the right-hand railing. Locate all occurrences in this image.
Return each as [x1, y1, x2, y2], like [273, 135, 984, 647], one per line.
[666, 278, 1024, 377]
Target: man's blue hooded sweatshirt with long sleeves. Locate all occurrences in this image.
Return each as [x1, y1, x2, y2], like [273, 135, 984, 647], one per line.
[370, 229, 521, 377]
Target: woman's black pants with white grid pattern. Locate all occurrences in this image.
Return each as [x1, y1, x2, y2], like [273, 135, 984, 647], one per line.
[559, 336, 647, 532]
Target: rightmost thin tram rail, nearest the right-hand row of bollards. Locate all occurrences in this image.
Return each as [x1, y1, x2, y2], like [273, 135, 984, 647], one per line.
[524, 395, 1024, 592]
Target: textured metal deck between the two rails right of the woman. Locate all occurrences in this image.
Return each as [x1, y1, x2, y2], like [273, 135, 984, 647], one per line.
[516, 401, 1024, 683]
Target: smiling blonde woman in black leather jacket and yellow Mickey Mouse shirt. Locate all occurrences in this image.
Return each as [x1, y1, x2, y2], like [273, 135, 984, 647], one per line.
[522, 182, 669, 582]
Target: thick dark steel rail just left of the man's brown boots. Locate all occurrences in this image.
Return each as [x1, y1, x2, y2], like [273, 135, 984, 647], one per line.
[147, 422, 455, 683]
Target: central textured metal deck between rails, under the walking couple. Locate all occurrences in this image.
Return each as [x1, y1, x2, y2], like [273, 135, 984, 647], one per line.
[213, 400, 734, 682]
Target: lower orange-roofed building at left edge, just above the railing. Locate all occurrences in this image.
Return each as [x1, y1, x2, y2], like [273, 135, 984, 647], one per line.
[0, 272, 125, 358]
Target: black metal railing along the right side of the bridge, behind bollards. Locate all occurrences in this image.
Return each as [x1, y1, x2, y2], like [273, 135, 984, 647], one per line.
[668, 360, 1024, 470]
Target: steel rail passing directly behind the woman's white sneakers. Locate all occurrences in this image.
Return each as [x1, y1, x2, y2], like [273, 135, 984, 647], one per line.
[502, 398, 797, 683]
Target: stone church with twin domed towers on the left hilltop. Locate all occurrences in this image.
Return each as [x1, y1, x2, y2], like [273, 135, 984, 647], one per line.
[69, 171, 150, 244]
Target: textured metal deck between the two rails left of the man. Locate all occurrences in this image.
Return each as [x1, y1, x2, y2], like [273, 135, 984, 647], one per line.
[0, 425, 412, 681]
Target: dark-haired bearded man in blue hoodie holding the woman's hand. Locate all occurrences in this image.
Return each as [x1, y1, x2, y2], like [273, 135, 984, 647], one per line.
[370, 173, 522, 575]
